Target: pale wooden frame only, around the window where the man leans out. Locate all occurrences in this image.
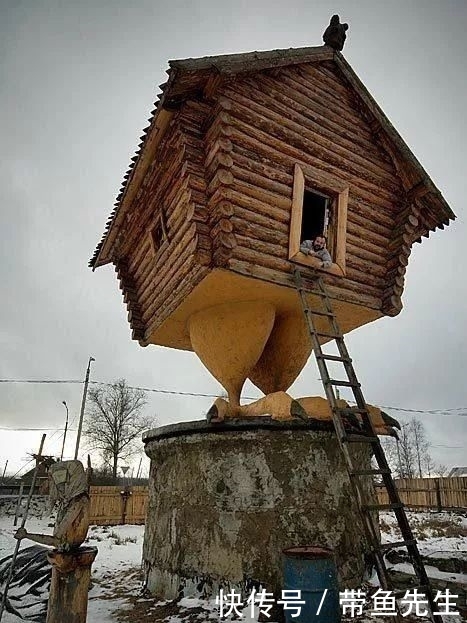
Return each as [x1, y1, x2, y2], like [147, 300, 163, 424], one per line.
[289, 164, 349, 277]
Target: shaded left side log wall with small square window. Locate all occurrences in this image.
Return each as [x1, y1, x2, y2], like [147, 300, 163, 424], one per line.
[117, 102, 212, 345]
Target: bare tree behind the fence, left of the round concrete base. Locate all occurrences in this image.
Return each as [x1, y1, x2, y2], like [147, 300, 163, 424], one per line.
[84, 379, 154, 478]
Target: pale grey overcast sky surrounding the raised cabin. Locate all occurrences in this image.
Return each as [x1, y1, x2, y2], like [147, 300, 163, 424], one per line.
[0, 0, 467, 478]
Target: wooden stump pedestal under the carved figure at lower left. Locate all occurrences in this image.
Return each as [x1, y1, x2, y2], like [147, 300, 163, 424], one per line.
[46, 547, 97, 623]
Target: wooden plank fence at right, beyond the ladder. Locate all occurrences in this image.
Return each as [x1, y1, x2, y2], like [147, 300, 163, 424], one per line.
[376, 477, 467, 510]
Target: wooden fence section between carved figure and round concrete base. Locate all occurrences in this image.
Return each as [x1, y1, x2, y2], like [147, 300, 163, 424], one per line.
[90, 486, 148, 526]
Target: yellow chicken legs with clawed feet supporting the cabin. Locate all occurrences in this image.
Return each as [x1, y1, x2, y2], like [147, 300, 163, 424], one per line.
[189, 301, 400, 436]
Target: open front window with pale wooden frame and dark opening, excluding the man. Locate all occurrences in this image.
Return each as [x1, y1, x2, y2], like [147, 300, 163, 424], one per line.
[289, 164, 349, 275]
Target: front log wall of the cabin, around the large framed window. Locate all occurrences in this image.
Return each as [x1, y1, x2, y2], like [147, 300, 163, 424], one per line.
[210, 64, 403, 309]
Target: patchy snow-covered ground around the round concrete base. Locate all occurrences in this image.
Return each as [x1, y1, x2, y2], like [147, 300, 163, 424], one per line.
[0, 513, 467, 623]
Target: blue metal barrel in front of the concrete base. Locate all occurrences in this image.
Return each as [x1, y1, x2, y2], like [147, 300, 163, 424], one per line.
[282, 547, 341, 623]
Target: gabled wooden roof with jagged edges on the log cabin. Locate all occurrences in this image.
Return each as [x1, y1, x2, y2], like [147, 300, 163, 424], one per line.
[89, 45, 456, 270]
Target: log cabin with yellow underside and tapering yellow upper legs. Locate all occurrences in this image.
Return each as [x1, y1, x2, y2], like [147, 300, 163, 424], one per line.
[90, 45, 455, 414]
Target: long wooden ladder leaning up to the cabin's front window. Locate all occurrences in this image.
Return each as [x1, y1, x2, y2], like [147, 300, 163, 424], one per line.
[294, 268, 443, 623]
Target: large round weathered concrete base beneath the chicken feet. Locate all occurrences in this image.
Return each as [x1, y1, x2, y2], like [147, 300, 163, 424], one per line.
[143, 418, 376, 599]
